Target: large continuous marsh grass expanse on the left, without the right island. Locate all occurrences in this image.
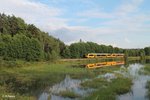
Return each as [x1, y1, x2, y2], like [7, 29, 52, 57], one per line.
[0, 61, 123, 100]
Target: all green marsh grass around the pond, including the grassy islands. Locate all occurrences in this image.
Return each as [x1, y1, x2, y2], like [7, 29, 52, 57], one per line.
[0, 58, 150, 100]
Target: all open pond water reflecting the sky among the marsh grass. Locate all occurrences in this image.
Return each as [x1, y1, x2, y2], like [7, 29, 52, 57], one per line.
[38, 61, 150, 100]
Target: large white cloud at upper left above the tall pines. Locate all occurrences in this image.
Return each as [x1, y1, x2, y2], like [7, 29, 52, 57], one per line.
[0, 0, 67, 31]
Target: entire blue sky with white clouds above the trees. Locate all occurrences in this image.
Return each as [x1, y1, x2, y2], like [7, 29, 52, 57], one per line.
[0, 0, 150, 48]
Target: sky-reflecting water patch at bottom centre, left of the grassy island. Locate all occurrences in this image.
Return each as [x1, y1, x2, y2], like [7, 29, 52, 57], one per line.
[38, 76, 92, 100]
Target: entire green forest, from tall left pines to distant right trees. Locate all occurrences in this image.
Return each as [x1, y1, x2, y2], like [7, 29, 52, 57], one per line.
[0, 14, 150, 61]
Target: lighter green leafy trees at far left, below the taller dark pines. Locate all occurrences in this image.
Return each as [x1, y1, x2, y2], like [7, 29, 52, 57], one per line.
[0, 35, 42, 61]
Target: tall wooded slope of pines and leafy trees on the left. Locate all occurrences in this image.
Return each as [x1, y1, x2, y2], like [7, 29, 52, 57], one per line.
[0, 14, 65, 61]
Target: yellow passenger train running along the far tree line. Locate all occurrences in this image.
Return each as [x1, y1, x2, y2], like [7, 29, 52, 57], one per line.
[84, 53, 124, 58]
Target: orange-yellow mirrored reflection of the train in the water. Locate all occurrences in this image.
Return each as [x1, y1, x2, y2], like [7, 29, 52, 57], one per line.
[86, 61, 125, 68]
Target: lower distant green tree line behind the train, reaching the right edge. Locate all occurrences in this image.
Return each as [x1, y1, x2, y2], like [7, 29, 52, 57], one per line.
[62, 42, 150, 58]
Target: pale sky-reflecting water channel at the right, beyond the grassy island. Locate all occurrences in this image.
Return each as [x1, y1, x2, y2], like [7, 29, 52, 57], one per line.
[118, 63, 150, 100]
